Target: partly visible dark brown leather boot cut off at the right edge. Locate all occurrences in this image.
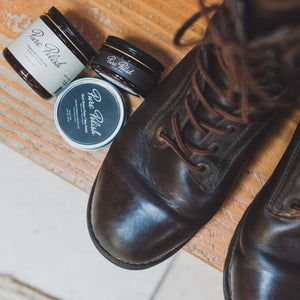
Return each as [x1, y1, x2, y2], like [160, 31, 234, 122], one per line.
[224, 123, 300, 300]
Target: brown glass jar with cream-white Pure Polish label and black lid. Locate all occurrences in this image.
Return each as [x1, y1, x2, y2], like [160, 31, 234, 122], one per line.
[3, 7, 96, 99]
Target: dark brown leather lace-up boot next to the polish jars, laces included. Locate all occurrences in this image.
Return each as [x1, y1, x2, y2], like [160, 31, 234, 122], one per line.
[88, 0, 300, 269]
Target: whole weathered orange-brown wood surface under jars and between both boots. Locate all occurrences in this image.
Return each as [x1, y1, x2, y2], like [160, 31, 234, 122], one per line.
[0, 0, 300, 270]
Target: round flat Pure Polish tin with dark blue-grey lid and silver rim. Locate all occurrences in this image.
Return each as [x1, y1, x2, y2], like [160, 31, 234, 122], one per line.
[54, 78, 126, 151]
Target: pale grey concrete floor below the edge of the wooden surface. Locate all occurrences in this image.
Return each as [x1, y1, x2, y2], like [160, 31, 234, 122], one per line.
[0, 144, 223, 300]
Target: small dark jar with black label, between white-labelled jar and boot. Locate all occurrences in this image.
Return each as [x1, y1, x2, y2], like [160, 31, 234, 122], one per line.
[91, 36, 164, 98]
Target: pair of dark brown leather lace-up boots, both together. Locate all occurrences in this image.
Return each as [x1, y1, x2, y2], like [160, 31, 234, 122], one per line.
[88, 0, 300, 300]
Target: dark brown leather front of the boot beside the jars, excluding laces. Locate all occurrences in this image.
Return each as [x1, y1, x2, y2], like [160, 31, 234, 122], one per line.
[88, 0, 300, 269]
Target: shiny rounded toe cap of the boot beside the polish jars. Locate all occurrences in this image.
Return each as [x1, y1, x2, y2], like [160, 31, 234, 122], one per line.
[88, 157, 194, 269]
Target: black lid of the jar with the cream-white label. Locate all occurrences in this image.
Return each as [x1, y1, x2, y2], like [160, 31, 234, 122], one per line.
[45, 6, 96, 64]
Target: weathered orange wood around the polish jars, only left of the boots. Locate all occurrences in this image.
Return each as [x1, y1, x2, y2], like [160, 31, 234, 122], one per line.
[0, 0, 203, 192]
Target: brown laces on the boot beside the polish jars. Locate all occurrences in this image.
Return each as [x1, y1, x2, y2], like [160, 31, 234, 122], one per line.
[157, 0, 300, 171]
